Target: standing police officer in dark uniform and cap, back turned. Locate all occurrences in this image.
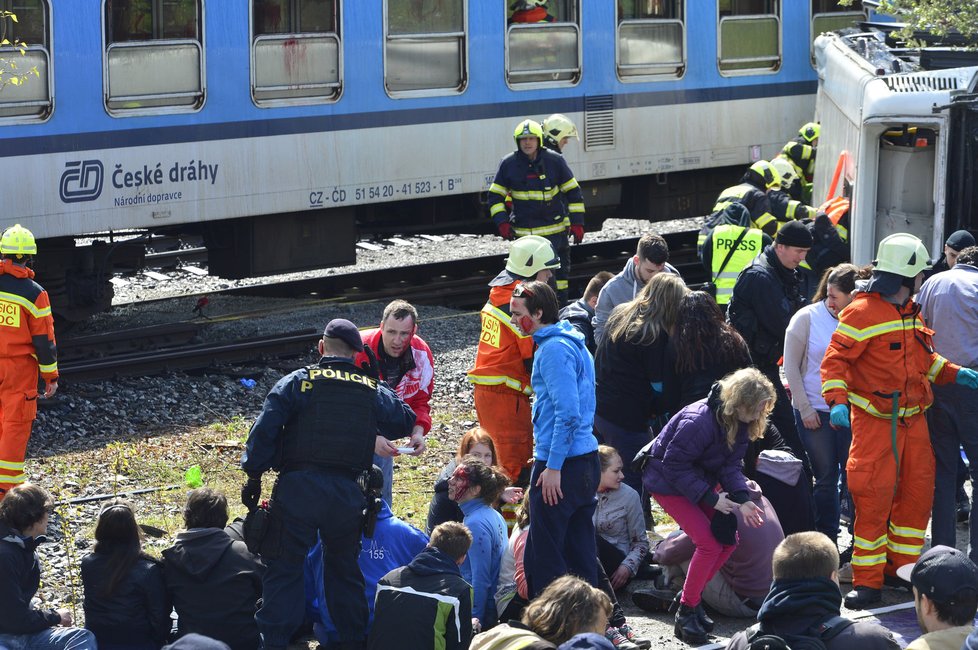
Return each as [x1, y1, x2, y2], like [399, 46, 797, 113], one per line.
[241, 318, 415, 650]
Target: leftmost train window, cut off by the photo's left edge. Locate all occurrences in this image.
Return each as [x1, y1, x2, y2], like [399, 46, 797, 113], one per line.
[0, 0, 53, 122]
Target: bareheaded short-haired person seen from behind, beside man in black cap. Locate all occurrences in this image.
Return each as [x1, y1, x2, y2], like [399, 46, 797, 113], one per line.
[727, 531, 900, 650]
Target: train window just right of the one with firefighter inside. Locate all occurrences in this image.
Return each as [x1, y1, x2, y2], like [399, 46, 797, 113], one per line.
[617, 0, 686, 81]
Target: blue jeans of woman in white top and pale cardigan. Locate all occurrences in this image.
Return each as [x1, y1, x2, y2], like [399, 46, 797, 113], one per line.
[792, 409, 852, 542]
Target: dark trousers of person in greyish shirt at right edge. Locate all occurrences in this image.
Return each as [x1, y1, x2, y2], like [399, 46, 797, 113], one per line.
[927, 384, 978, 561]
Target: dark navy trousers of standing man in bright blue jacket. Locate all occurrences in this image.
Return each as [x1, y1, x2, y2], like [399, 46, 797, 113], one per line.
[523, 451, 601, 599]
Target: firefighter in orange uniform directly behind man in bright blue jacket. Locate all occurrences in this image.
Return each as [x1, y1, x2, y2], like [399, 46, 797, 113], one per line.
[468, 235, 560, 482]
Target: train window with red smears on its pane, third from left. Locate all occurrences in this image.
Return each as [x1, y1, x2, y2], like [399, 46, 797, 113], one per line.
[251, 0, 343, 106]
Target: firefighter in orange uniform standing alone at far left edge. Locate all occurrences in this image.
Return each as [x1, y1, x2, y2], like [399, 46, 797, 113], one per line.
[0, 224, 58, 499]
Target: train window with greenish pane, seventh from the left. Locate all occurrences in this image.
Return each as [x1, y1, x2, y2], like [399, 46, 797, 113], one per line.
[717, 0, 781, 76]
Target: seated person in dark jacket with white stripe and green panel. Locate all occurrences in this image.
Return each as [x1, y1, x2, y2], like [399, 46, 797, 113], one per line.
[367, 521, 473, 650]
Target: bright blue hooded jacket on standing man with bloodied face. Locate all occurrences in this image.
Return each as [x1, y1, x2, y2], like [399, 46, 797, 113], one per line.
[530, 321, 598, 471]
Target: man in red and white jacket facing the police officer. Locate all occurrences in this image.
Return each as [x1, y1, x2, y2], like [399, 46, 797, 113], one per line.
[354, 300, 435, 505]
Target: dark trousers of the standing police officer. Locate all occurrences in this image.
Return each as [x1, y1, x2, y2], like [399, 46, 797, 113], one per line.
[255, 470, 367, 648]
